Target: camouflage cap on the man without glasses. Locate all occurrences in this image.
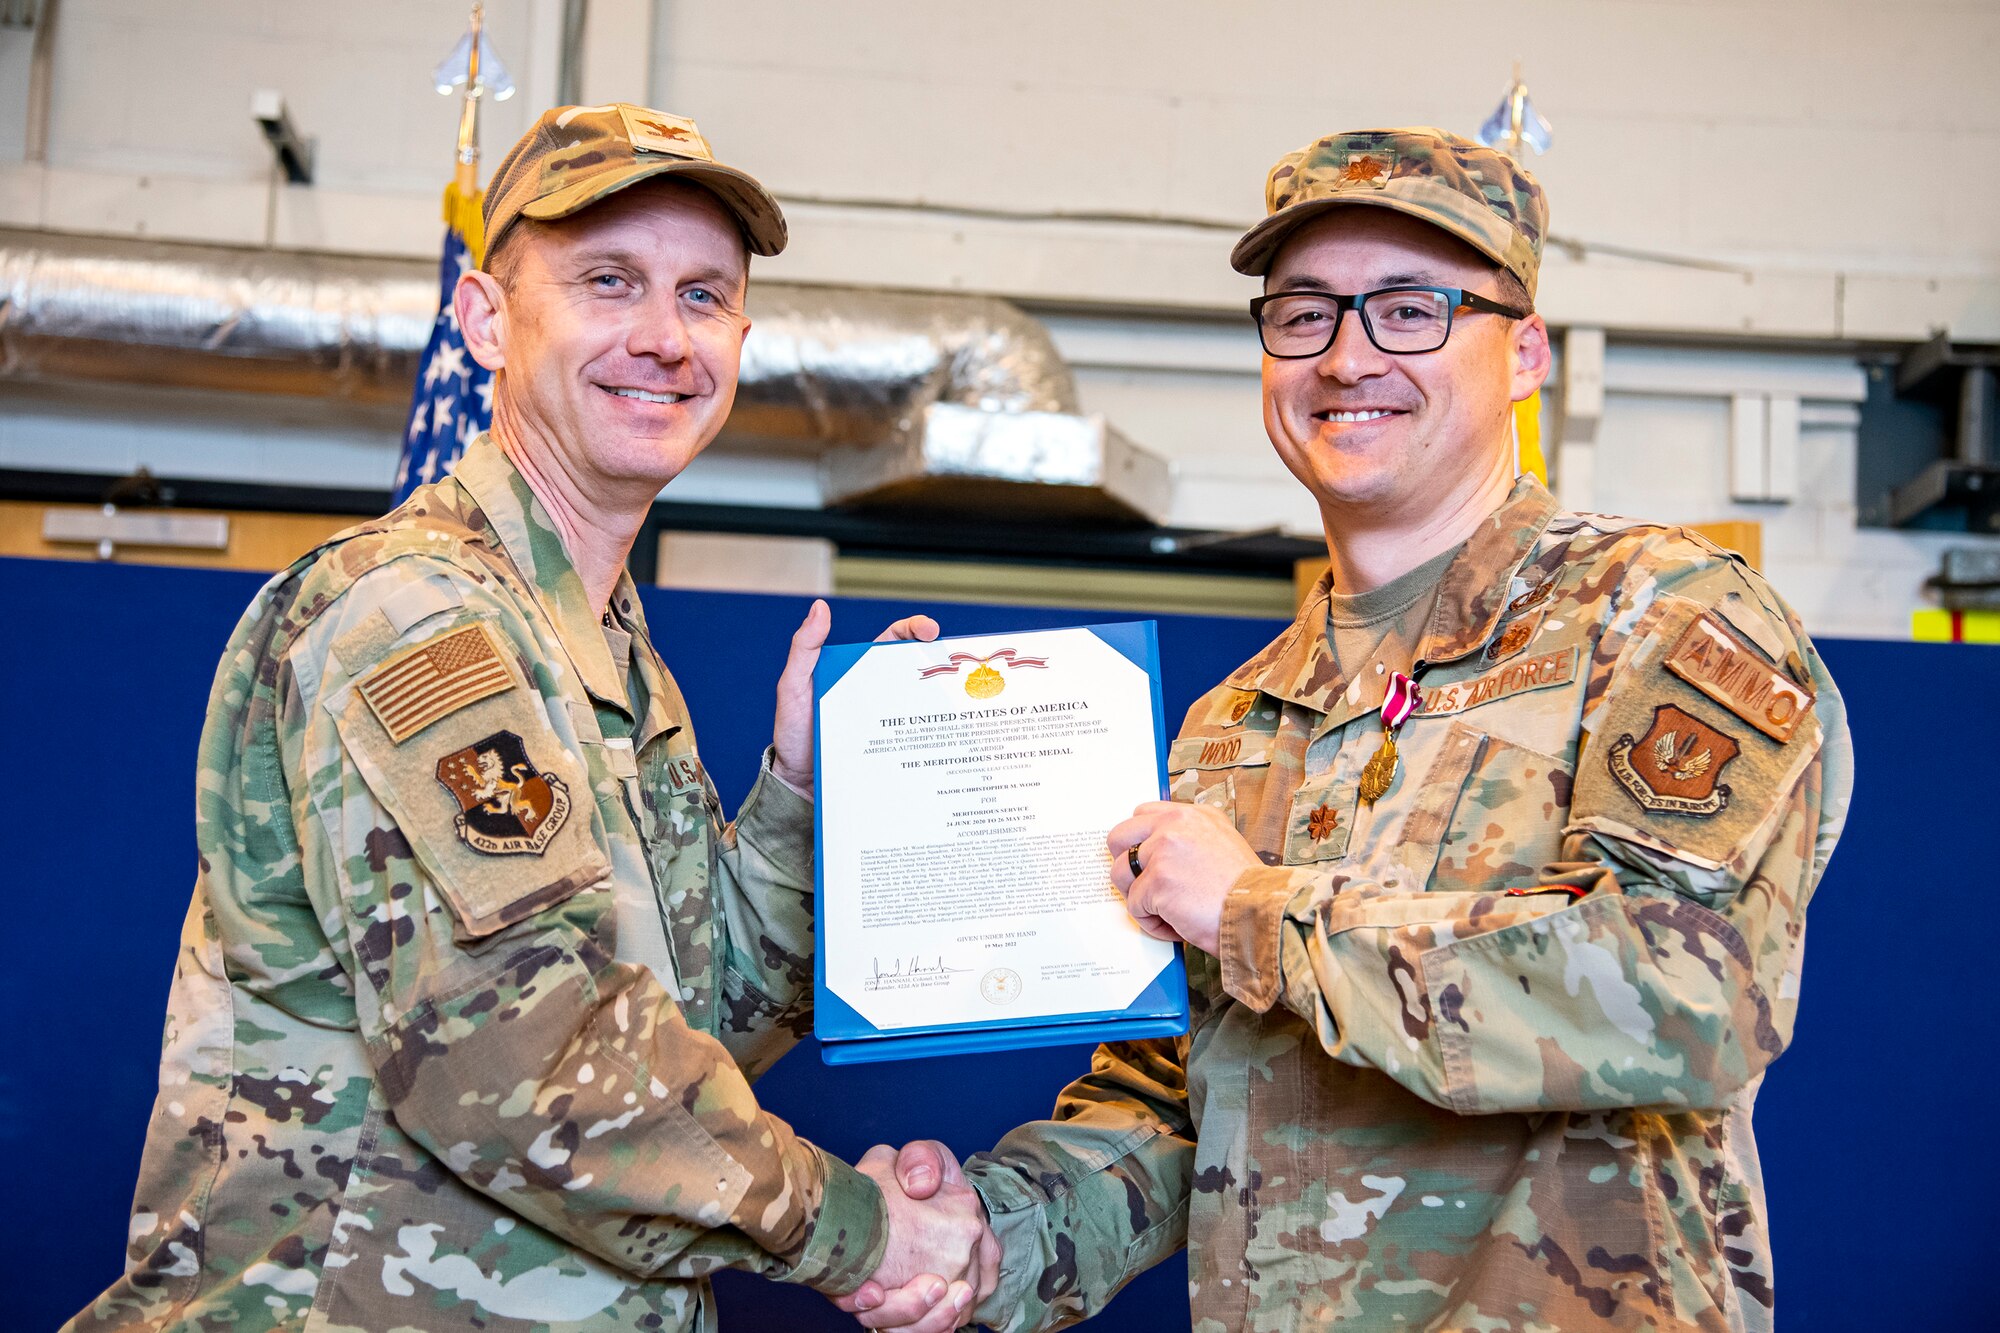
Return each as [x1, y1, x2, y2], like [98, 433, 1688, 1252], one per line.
[486, 102, 786, 264]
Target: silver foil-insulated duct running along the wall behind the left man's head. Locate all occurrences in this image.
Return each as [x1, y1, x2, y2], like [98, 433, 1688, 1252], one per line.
[0, 230, 1172, 522]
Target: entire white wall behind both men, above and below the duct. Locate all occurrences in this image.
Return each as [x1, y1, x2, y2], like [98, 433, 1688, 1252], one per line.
[0, 0, 2000, 634]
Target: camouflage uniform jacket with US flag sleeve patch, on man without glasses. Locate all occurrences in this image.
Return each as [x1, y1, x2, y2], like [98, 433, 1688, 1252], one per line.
[72, 438, 884, 1333]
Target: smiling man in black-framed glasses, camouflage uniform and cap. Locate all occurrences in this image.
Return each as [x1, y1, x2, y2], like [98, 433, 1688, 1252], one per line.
[864, 130, 1852, 1333]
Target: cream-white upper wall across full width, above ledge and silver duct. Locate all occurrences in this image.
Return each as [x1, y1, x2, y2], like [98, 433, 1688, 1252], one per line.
[0, 0, 2000, 338]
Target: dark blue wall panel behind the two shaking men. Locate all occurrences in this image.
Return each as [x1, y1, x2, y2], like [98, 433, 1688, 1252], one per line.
[0, 560, 2000, 1333]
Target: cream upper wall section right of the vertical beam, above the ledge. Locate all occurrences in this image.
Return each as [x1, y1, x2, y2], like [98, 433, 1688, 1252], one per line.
[676, 0, 2000, 336]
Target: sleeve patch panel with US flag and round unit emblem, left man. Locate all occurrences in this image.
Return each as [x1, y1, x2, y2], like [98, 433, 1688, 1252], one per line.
[324, 620, 610, 941]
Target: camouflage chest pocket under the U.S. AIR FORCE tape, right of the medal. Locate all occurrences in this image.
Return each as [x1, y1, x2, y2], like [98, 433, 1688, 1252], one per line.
[1396, 723, 1572, 893]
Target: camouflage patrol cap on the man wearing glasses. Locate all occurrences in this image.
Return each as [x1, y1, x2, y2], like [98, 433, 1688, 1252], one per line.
[1230, 126, 1548, 296]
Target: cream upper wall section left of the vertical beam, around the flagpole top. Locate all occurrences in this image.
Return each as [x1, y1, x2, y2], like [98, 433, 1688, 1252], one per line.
[0, 0, 560, 254]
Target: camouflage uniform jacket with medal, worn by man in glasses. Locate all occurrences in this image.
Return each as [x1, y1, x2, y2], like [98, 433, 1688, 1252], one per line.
[970, 480, 1850, 1333]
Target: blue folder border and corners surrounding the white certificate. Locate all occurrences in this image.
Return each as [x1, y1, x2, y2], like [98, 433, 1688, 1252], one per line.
[812, 620, 1188, 1065]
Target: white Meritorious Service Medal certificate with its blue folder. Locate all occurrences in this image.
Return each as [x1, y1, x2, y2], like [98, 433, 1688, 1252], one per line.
[816, 622, 1186, 1063]
